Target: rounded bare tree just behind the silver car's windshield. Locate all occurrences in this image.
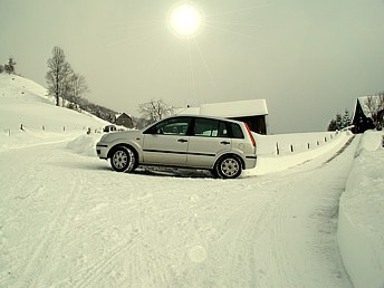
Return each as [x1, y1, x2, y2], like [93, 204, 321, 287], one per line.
[139, 99, 174, 123]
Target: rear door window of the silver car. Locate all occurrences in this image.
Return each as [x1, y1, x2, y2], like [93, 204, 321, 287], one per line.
[192, 118, 228, 137]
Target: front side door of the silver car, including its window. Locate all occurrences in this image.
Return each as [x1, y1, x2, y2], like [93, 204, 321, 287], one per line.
[143, 117, 191, 166]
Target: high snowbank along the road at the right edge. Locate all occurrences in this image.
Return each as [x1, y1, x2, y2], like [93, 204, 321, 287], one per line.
[338, 132, 384, 288]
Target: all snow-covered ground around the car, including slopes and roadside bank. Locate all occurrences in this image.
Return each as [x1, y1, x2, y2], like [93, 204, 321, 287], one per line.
[0, 75, 384, 287]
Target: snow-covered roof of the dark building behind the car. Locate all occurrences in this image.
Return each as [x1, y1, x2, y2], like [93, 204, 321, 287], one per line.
[176, 99, 268, 117]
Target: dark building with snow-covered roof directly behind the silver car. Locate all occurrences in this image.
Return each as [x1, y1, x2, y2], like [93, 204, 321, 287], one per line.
[175, 99, 268, 135]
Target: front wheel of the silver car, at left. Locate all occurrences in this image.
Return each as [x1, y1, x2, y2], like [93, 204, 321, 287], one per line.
[111, 146, 137, 172]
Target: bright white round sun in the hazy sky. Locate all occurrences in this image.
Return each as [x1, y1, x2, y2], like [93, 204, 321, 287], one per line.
[169, 3, 202, 38]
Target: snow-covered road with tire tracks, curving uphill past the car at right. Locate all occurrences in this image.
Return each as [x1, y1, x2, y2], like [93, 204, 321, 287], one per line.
[0, 135, 357, 287]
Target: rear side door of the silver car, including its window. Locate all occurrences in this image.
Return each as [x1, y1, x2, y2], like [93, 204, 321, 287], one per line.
[187, 118, 232, 168]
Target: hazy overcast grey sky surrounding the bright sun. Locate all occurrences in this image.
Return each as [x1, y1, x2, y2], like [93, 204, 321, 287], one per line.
[0, 0, 384, 133]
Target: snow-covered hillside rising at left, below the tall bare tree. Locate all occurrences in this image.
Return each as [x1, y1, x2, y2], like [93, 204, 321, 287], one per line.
[0, 74, 107, 150]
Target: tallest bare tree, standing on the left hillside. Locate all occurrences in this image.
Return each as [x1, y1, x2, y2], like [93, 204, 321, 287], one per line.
[46, 47, 73, 106]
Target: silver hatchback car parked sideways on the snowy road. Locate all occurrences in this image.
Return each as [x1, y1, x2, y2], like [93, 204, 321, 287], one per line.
[96, 115, 257, 178]
